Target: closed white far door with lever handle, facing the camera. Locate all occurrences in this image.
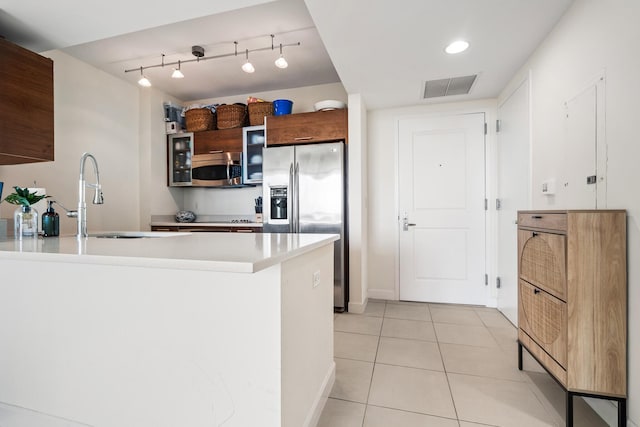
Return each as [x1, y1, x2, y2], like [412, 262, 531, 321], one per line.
[398, 113, 486, 305]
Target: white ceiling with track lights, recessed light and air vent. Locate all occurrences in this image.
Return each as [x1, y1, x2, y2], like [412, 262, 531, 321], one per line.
[0, 0, 571, 108]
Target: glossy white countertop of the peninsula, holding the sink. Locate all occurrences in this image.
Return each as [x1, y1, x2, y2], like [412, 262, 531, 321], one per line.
[0, 232, 340, 273]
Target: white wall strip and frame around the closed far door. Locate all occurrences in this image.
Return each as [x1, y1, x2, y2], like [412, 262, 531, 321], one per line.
[367, 100, 497, 305]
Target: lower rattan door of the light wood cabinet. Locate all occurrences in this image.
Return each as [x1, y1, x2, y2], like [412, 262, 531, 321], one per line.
[518, 280, 567, 369]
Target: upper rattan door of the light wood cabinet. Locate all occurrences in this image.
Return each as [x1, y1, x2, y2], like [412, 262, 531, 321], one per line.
[518, 230, 567, 302]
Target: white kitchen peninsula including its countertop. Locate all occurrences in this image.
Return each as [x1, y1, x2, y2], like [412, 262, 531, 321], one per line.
[0, 232, 337, 427]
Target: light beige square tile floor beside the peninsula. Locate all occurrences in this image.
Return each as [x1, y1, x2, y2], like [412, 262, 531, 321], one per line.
[318, 300, 607, 427]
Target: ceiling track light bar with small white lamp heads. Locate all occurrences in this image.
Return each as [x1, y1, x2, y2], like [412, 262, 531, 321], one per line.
[124, 34, 300, 87]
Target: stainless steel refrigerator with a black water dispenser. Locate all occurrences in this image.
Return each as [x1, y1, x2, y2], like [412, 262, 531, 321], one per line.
[262, 142, 349, 311]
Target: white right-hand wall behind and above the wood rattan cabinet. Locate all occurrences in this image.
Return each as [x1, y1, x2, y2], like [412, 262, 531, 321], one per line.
[501, 0, 640, 426]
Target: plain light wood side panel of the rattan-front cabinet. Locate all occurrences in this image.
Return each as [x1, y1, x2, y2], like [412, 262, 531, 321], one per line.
[567, 213, 627, 396]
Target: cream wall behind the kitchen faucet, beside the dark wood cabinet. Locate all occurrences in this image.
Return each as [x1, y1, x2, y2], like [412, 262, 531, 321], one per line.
[0, 51, 140, 234]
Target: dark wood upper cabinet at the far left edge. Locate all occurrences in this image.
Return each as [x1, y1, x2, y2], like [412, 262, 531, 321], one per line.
[0, 38, 53, 165]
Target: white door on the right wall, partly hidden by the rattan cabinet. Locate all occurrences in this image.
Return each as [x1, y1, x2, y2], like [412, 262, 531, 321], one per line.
[496, 80, 531, 325]
